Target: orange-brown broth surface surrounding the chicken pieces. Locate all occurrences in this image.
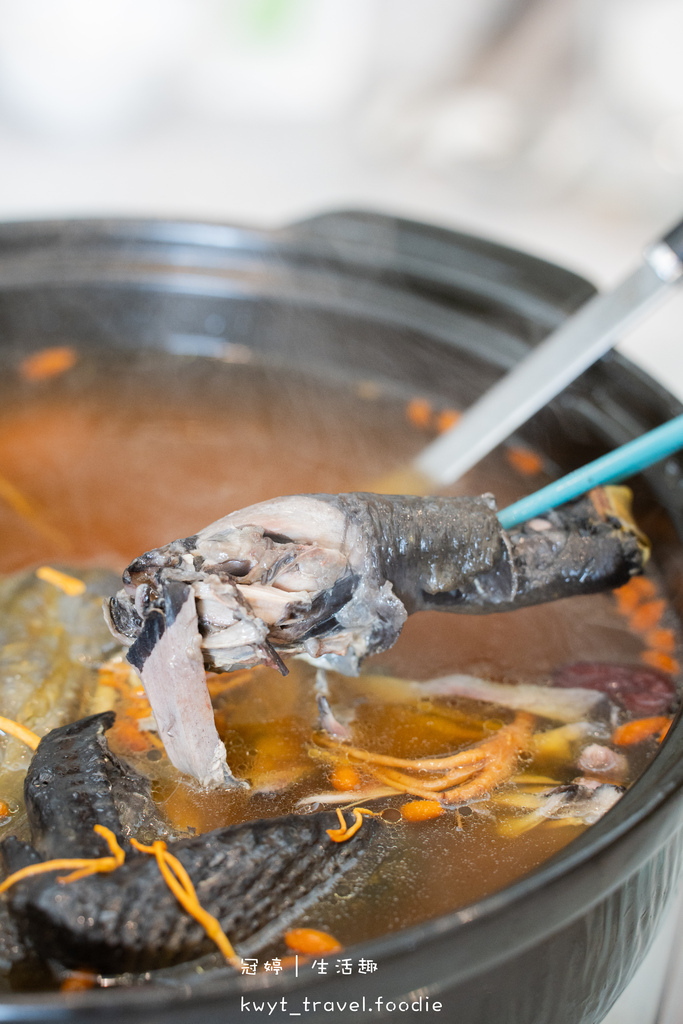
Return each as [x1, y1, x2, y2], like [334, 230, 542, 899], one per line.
[0, 349, 679, 987]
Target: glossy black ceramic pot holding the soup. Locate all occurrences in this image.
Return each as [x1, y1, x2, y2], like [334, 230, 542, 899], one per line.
[0, 213, 683, 1024]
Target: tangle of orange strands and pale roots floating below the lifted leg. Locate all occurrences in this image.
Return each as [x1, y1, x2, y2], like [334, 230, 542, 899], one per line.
[302, 676, 643, 835]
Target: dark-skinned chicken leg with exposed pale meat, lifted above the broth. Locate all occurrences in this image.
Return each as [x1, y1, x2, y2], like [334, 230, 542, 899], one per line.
[108, 488, 648, 786]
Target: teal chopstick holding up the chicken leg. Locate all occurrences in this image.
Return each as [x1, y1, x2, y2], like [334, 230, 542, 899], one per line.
[498, 416, 683, 529]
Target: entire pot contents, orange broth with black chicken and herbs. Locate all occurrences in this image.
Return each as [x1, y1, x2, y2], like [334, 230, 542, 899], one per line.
[0, 346, 680, 989]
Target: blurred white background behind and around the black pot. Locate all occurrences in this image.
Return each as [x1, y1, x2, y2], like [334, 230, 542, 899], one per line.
[0, 0, 683, 1024]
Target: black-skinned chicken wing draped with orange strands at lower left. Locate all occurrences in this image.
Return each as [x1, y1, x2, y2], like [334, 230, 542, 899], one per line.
[0, 712, 380, 974]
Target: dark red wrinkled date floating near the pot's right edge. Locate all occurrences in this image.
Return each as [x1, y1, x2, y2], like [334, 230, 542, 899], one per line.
[553, 662, 676, 715]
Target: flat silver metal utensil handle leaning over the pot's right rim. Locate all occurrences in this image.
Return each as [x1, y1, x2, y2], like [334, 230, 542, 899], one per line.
[413, 221, 683, 487]
